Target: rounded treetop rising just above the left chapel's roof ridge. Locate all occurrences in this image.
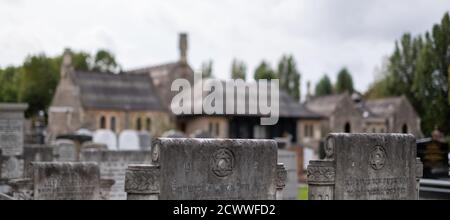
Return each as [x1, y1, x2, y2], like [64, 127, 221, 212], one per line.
[91, 49, 120, 73]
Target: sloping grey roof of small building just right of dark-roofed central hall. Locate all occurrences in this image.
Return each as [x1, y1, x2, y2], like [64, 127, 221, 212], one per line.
[305, 93, 348, 116]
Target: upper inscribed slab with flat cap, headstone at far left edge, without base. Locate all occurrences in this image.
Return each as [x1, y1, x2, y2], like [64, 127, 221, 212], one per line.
[0, 104, 28, 157]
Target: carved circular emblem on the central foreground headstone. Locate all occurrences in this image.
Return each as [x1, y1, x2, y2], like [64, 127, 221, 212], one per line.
[211, 148, 234, 177]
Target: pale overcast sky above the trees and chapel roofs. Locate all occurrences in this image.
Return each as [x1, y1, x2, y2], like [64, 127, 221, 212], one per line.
[0, 0, 450, 94]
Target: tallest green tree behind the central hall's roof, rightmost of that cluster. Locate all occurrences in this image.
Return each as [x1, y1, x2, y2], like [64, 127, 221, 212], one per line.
[278, 55, 300, 100]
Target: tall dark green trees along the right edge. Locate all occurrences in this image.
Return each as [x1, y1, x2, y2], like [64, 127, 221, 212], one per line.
[366, 13, 450, 135]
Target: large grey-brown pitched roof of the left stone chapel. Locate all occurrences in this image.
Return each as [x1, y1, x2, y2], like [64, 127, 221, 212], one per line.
[72, 71, 164, 111]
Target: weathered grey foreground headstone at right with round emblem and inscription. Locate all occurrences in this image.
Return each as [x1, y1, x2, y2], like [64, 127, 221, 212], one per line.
[308, 134, 421, 200]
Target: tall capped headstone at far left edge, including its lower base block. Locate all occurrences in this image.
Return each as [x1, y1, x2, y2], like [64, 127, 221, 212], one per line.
[0, 104, 28, 185]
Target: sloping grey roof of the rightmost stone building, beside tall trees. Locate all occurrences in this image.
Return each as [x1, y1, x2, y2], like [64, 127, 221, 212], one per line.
[364, 97, 402, 117]
